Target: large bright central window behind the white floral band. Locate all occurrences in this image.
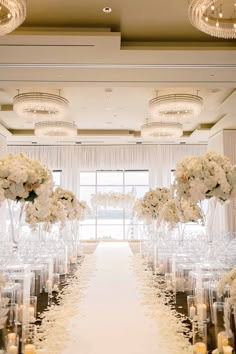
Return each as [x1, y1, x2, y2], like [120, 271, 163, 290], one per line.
[80, 170, 149, 240]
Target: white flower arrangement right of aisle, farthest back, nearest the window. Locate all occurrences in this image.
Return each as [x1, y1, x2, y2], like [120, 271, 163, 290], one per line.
[133, 188, 171, 223]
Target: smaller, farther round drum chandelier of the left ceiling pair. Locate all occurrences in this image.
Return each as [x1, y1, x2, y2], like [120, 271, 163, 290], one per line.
[34, 121, 77, 137]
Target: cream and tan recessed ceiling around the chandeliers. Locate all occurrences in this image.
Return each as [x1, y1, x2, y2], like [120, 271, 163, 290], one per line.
[0, 0, 236, 144]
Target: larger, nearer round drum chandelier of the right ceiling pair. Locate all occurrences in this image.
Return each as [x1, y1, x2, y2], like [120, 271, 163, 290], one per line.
[149, 94, 203, 120]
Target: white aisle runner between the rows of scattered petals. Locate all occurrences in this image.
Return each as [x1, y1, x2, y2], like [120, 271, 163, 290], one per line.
[60, 243, 160, 354]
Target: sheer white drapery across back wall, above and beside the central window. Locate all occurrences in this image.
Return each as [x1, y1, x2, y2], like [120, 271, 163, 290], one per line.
[9, 145, 207, 193]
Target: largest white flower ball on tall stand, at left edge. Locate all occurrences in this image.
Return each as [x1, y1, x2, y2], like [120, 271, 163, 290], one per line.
[0, 154, 52, 203]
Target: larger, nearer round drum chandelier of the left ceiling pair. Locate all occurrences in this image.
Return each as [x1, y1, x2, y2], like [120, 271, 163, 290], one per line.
[13, 92, 69, 120]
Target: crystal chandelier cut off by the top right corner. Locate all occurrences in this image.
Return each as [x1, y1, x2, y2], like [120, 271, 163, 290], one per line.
[188, 0, 236, 39]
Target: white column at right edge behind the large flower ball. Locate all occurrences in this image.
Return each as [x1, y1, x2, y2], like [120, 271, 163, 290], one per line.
[208, 130, 236, 232]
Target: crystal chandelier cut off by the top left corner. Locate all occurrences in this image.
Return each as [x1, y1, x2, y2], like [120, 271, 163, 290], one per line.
[0, 0, 26, 36]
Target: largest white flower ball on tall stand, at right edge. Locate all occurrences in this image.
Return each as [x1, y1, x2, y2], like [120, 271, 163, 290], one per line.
[175, 152, 236, 202]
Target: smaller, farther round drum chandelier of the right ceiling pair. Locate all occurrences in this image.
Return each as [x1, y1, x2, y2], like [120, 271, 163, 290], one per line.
[141, 122, 183, 140]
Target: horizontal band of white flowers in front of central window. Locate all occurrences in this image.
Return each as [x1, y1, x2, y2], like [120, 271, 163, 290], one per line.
[91, 192, 135, 209]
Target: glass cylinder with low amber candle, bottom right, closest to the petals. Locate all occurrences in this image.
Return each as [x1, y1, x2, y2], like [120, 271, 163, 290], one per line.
[193, 321, 207, 354]
